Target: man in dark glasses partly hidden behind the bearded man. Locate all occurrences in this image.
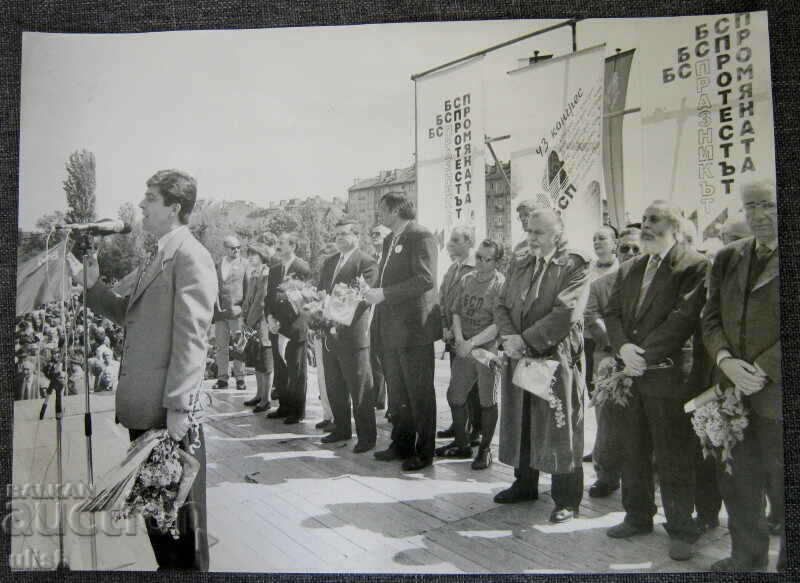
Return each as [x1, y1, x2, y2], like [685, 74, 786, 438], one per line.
[584, 227, 641, 498]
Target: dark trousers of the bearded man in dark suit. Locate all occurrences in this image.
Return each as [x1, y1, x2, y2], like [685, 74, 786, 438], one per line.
[622, 391, 699, 542]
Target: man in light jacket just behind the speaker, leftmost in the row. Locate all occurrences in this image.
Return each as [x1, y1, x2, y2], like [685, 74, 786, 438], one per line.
[214, 235, 247, 390]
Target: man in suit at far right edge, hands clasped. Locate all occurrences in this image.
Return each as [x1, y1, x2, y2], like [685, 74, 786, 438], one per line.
[703, 181, 785, 571]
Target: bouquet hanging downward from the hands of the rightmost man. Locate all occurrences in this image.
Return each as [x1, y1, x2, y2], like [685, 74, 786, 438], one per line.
[684, 385, 749, 474]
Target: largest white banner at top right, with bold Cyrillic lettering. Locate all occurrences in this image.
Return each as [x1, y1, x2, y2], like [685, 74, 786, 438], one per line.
[631, 12, 775, 246]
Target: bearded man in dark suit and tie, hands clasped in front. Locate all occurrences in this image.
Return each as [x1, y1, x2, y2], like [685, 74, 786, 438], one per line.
[606, 200, 707, 560]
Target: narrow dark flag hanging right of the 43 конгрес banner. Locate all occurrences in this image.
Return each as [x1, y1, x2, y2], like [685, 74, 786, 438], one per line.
[603, 49, 636, 229]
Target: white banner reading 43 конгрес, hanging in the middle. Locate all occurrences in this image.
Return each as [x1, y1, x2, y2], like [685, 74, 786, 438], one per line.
[509, 45, 605, 253]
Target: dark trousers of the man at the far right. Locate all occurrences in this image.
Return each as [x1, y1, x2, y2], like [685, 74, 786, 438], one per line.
[718, 411, 785, 565]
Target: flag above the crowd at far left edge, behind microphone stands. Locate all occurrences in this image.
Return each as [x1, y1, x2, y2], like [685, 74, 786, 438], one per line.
[17, 239, 72, 316]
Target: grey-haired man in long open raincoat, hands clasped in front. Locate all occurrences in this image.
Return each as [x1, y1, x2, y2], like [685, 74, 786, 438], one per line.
[494, 209, 590, 523]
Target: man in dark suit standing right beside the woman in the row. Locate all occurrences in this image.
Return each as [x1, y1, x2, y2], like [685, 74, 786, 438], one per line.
[264, 233, 311, 425]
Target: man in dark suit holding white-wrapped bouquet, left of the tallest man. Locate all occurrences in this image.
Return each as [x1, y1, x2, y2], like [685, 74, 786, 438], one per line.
[319, 220, 378, 453]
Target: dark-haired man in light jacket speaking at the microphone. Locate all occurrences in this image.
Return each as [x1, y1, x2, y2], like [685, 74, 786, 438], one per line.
[79, 170, 218, 570]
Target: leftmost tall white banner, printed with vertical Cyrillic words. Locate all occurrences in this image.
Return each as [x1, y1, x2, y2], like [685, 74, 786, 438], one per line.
[415, 57, 486, 278]
